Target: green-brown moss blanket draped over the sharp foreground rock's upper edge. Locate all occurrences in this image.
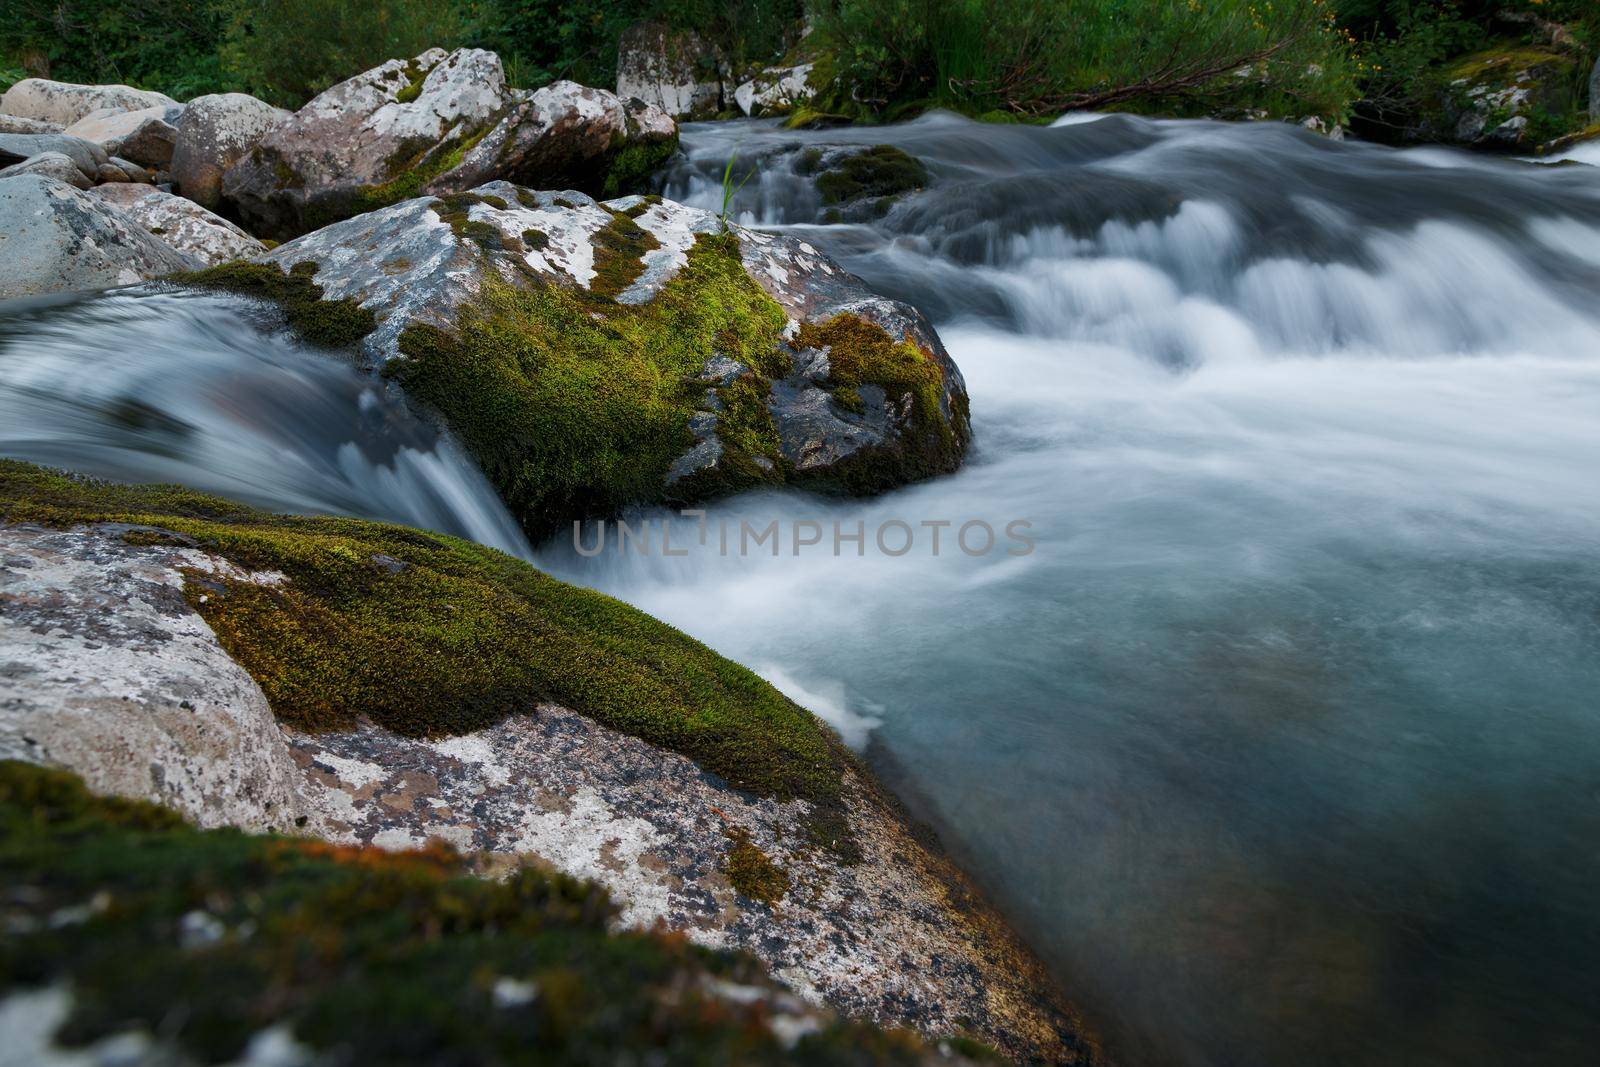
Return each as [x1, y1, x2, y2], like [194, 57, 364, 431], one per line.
[0, 460, 851, 854]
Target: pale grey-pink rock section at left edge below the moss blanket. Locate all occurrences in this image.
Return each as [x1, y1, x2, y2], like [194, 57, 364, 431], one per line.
[0, 526, 301, 829]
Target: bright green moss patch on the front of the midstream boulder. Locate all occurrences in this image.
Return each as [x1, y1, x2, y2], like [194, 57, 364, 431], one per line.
[386, 230, 787, 537]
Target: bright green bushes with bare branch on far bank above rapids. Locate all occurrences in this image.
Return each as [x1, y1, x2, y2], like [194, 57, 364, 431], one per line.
[806, 0, 1354, 117]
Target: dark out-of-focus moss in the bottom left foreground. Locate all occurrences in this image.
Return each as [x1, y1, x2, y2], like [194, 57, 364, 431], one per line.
[0, 761, 933, 1067]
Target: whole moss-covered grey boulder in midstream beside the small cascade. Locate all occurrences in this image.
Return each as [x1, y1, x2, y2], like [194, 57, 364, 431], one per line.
[230, 182, 970, 536]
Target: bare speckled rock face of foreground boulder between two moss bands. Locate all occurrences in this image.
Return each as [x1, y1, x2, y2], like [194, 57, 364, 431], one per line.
[0, 525, 1091, 1062]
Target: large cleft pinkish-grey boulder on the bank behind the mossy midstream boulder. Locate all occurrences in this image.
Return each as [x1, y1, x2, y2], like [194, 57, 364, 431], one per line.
[222, 48, 677, 237]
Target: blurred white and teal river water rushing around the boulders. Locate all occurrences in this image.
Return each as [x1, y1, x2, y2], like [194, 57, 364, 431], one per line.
[0, 115, 1600, 1065]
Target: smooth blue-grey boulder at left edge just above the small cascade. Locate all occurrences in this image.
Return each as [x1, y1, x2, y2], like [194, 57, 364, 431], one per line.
[0, 174, 200, 299]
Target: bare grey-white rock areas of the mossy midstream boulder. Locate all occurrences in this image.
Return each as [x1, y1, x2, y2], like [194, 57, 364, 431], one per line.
[262, 182, 966, 488]
